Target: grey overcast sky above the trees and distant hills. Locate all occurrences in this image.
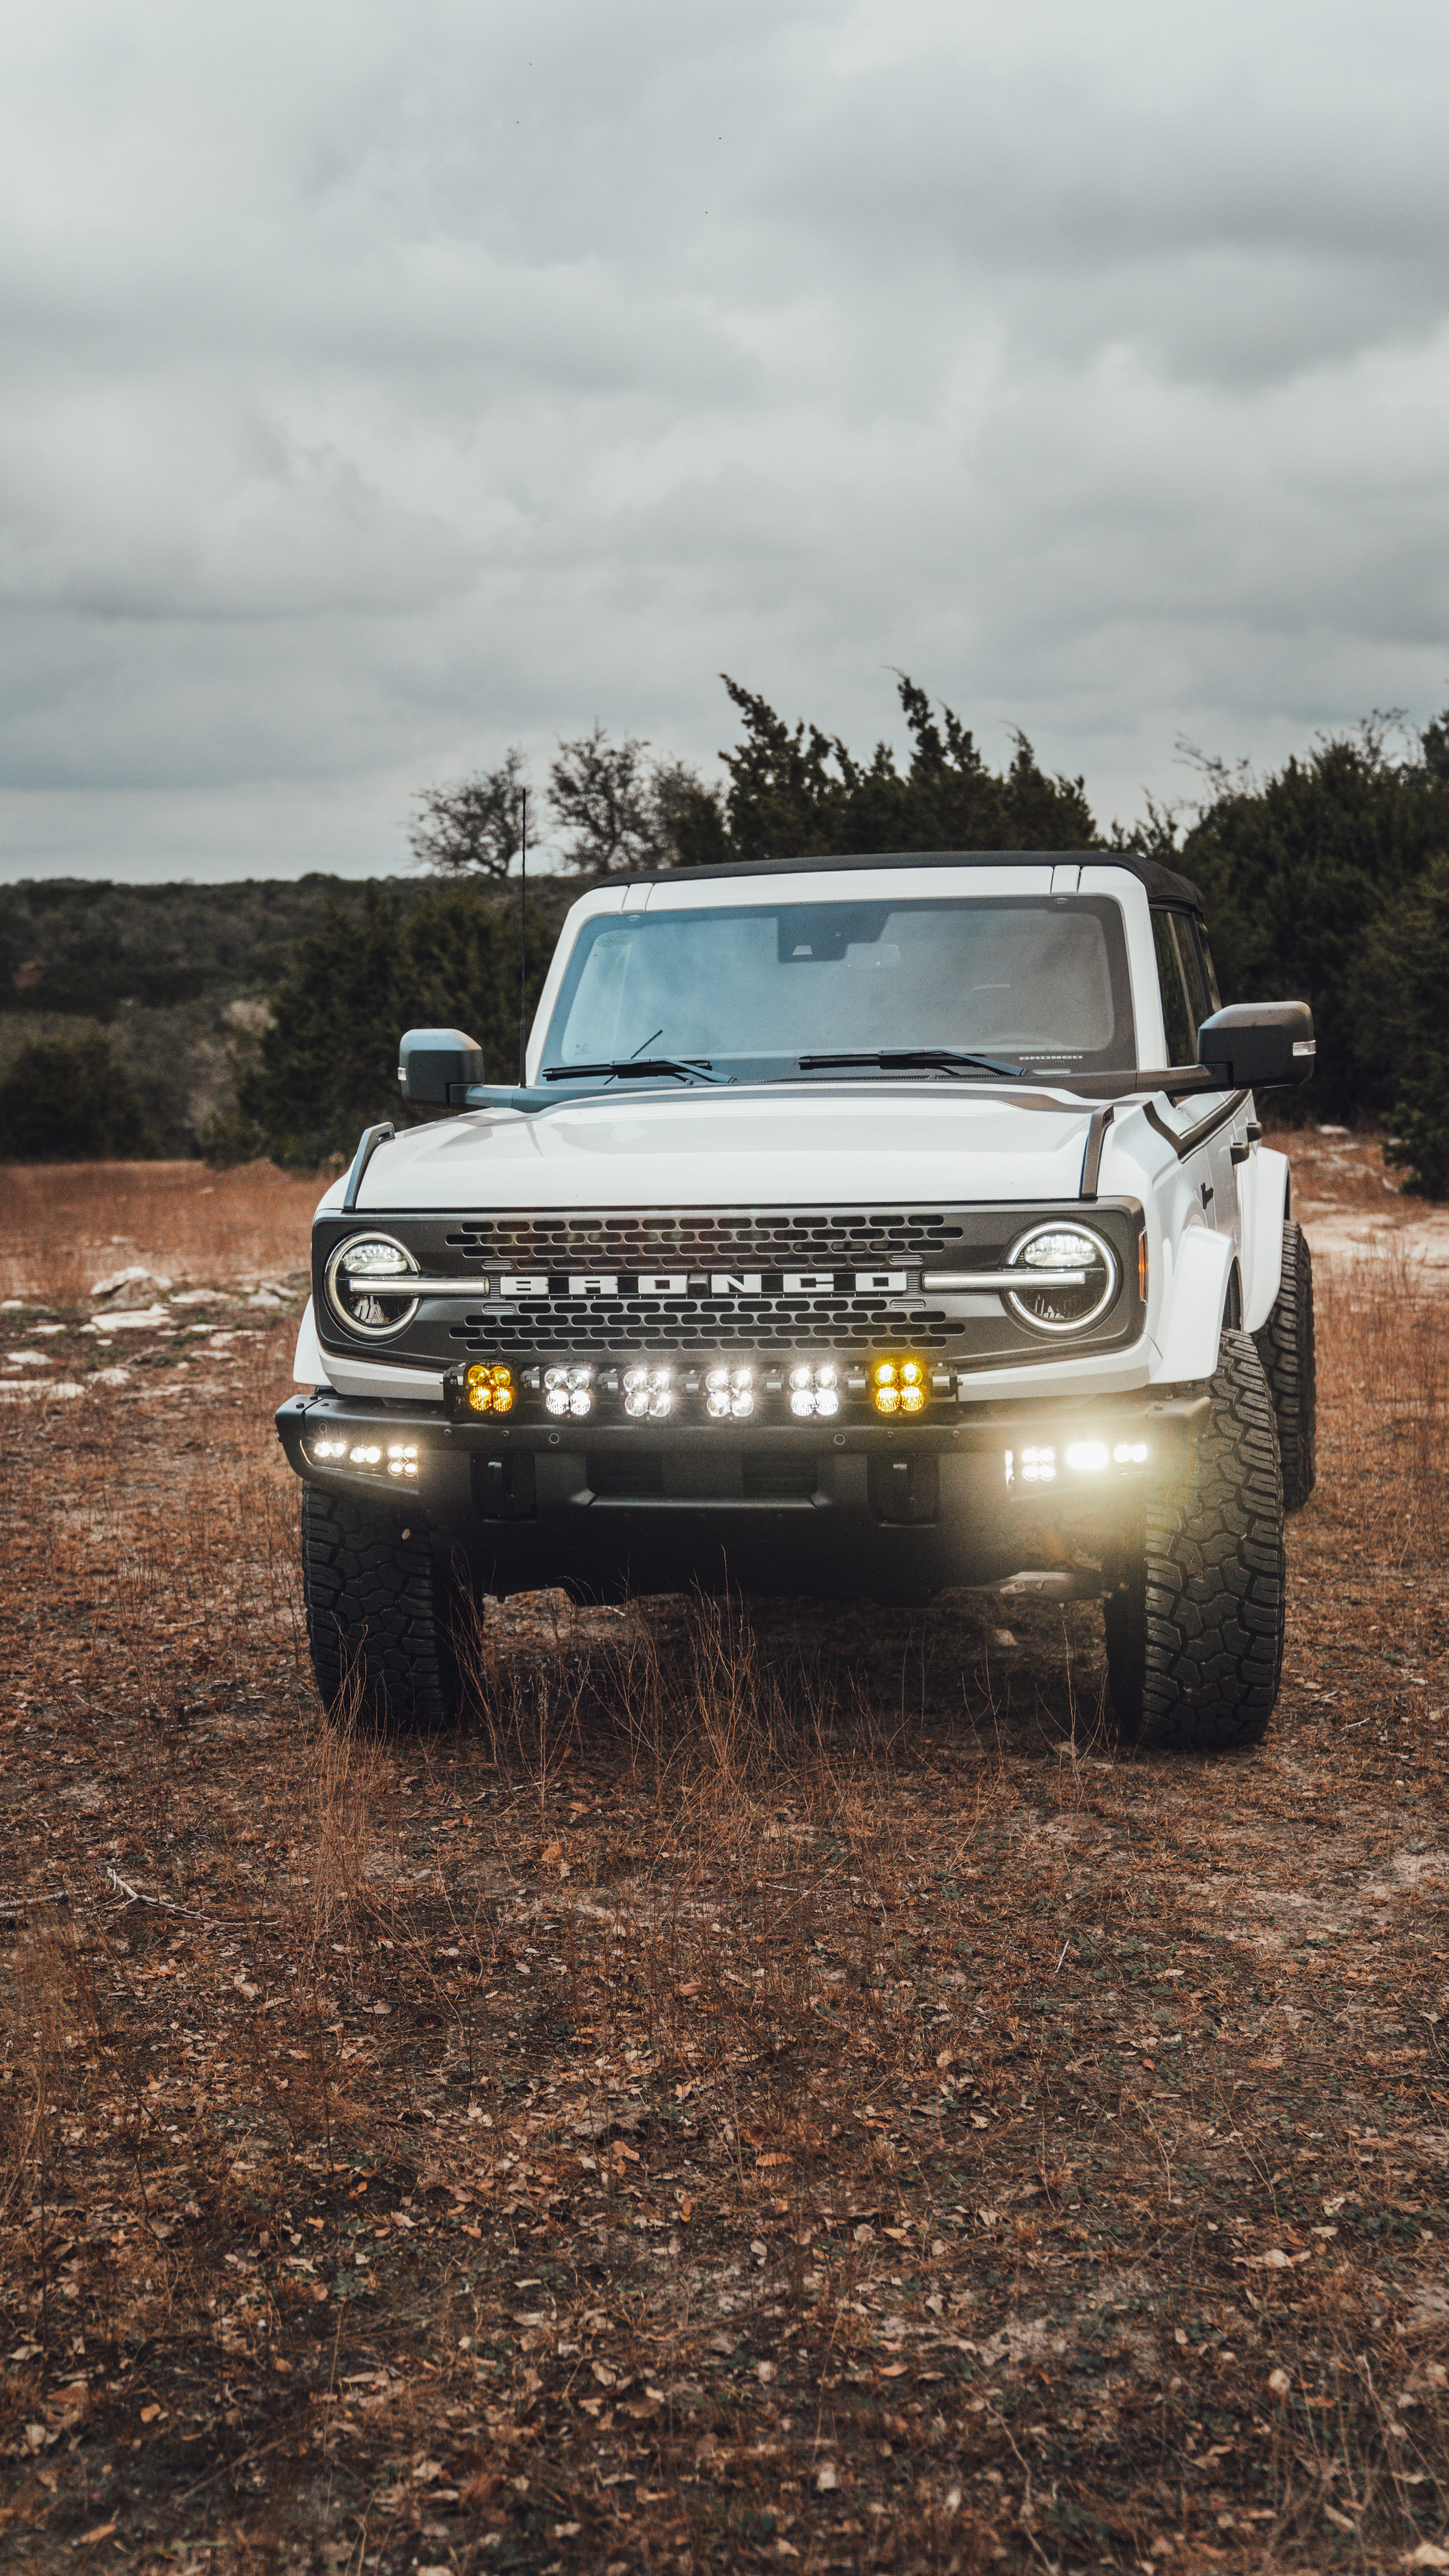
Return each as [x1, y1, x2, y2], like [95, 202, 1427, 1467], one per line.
[0, 0, 1449, 879]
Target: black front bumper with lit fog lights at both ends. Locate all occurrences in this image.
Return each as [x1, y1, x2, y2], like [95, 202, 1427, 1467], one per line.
[276, 1394, 1207, 1602]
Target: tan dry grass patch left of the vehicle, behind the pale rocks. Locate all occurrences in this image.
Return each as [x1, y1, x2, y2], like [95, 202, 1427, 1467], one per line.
[0, 1162, 322, 1309]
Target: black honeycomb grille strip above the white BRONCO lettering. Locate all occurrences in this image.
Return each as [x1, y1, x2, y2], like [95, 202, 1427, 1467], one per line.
[444, 1208, 964, 1270]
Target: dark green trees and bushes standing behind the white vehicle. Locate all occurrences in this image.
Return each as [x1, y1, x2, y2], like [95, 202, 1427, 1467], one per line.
[0, 675, 1449, 1195]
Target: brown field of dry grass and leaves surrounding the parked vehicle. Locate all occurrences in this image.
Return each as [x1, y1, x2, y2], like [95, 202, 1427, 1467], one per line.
[0, 1139, 1449, 2576]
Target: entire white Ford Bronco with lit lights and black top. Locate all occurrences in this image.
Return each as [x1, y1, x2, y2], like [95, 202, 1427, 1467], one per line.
[278, 850, 1315, 1752]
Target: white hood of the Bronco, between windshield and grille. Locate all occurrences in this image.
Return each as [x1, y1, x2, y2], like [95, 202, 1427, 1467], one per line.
[338, 1082, 1091, 1216]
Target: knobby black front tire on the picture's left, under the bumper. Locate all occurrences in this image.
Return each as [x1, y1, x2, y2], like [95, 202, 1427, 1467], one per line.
[302, 1484, 459, 1726]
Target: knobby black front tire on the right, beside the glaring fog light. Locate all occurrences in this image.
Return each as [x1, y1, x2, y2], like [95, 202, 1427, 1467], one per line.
[1106, 1329, 1284, 1754]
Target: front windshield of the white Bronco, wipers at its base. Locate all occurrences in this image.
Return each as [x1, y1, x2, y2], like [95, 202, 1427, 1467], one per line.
[544, 894, 1137, 1082]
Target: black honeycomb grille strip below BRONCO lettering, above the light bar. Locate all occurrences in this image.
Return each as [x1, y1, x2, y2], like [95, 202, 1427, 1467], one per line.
[449, 1291, 962, 1360]
